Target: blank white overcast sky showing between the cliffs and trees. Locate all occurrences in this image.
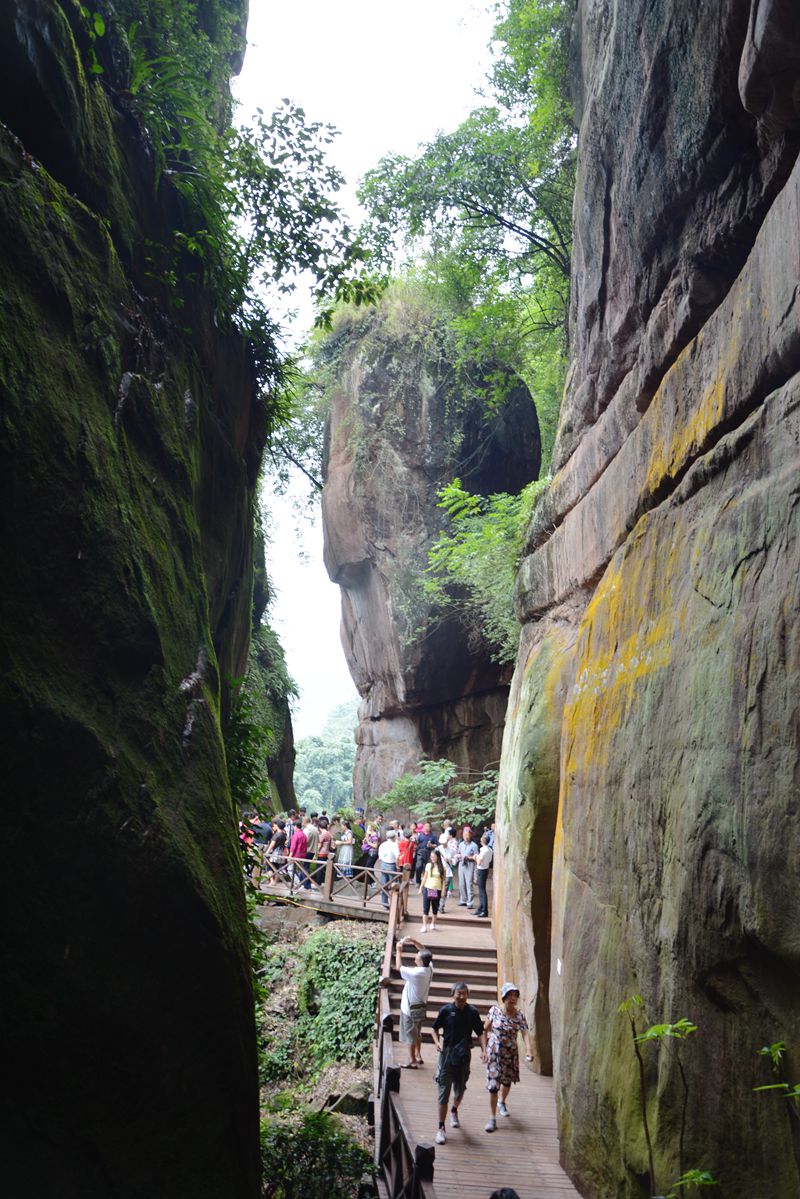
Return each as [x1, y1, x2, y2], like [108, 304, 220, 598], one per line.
[234, 0, 492, 737]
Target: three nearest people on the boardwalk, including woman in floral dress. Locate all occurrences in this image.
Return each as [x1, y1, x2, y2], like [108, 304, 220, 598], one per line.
[395, 936, 534, 1145]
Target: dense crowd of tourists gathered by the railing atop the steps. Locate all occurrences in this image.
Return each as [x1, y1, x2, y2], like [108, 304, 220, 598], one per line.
[239, 808, 494, 933]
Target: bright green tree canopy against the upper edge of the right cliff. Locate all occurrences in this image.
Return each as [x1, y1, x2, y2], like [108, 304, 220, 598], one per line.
[359, 0, 576, 463]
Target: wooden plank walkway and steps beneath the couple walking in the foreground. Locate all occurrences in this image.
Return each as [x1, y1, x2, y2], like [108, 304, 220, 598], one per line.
[390, 890, 581, 1199]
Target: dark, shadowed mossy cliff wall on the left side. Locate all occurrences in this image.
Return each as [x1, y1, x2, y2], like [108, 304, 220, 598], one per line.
[0, 0, 263, 1199]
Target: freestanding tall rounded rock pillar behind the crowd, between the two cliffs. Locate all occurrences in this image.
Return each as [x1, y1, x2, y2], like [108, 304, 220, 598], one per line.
[323, 295, 540, 802]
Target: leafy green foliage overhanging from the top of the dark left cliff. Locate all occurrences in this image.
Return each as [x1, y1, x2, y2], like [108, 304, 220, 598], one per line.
[82, 0, 378, 402]
